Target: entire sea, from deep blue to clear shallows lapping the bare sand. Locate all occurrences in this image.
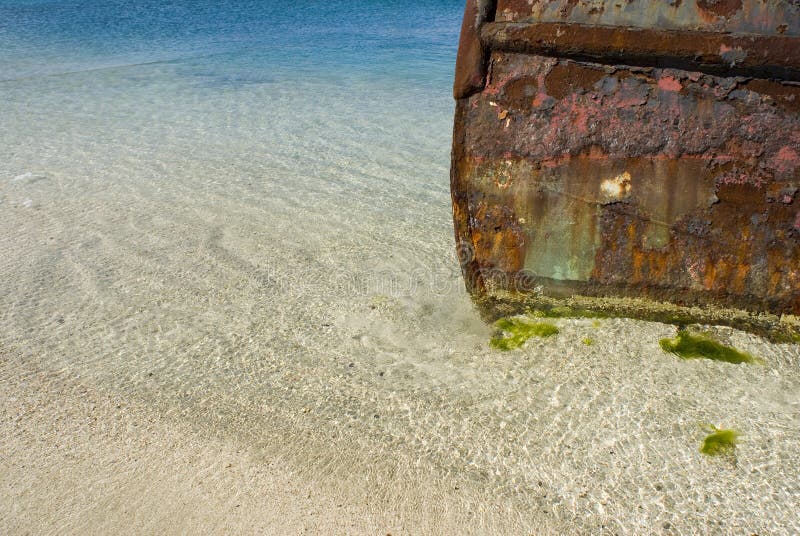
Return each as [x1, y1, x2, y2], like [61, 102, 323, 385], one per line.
[0, 0, 800, 534]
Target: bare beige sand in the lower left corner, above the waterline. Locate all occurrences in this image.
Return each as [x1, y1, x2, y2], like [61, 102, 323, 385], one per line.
[0, 356, 524, 534]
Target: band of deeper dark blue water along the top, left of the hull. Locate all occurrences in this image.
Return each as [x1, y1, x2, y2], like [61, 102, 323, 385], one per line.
[0, 0, 462, 85]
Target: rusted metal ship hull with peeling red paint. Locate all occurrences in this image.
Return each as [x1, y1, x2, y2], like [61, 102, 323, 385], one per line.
[451, 0, 800, 340]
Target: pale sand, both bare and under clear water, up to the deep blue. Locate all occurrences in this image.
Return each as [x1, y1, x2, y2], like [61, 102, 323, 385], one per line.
[0, 64, 800, 535]
